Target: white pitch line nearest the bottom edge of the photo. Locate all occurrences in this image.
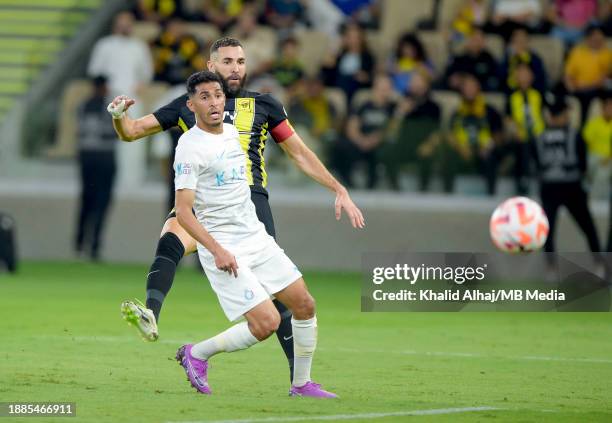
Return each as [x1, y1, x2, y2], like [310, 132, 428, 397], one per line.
[166, 407, 503, 423]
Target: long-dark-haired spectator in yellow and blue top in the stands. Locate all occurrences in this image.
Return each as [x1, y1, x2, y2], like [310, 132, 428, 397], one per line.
[389, 33, 434, 93]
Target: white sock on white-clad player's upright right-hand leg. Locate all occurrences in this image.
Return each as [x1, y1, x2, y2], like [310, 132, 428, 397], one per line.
[291, 316, 317, 386]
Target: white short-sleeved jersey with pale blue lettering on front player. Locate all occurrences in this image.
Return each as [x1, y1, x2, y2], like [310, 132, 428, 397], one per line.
[174, 123, 273, 254]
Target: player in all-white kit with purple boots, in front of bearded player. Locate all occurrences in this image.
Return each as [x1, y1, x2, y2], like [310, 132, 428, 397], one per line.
[174, 71, 337, 398]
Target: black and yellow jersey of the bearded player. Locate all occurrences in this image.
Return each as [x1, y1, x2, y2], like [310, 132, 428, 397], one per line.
[153, 90, 287, 192]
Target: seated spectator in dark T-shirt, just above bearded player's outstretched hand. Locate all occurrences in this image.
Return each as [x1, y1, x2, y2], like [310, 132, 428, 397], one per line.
[332, 74, 395, 189]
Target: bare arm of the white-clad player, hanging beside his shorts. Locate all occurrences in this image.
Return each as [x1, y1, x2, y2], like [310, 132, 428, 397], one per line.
[175, 189, 238, 277]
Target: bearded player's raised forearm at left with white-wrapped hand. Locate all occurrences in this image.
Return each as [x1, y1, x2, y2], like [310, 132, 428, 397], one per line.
[106, 95, 163, 142]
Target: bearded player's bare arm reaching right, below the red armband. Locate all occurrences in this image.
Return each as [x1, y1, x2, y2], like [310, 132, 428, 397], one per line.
[279, 133, 365, 229]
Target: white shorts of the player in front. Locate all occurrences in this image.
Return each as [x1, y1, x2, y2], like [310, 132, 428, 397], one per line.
[198, 241, 302, 322]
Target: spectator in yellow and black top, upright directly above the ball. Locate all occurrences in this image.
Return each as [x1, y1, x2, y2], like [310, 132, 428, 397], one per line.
[506, 63, 546, 195]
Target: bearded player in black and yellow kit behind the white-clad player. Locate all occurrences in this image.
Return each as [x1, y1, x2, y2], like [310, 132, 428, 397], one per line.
[108, 38, 365, 380]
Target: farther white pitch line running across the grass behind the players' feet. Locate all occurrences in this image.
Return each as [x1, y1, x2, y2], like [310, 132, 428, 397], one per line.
[39, 335, 612, 364]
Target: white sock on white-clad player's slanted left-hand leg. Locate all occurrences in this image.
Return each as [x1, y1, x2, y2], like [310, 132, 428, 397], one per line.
[191, 322, 259, 360]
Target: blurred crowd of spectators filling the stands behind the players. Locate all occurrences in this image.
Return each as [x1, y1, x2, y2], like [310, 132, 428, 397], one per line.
[82, 0, 612, 195]
